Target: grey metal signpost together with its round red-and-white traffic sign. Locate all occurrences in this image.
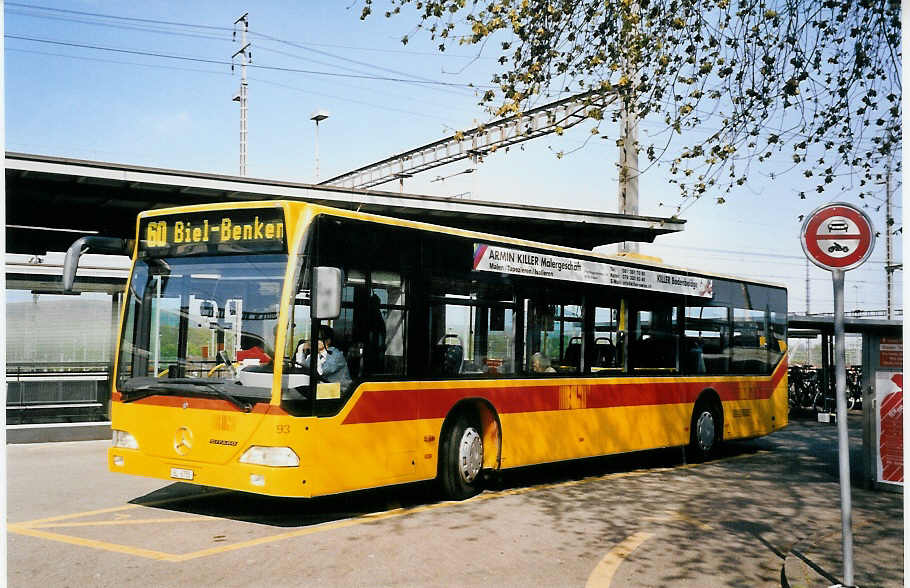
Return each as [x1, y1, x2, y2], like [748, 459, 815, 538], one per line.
[799, 202, 875, 586]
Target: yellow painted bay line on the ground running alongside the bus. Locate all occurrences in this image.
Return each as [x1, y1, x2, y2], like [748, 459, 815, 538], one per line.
[8, 451, 768, 566]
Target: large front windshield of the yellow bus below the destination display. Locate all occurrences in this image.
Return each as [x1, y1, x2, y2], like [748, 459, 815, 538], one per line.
[117, 254, 287, 408]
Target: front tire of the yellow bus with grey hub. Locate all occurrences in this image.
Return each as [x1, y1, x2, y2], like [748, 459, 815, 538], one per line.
[439, 415, 483, 500]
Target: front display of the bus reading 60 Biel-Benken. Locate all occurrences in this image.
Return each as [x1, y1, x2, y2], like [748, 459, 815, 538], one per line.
[139, 208, 287, 257]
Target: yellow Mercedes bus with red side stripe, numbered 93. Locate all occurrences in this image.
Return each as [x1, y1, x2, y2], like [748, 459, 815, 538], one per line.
[64, 201, 787, 499]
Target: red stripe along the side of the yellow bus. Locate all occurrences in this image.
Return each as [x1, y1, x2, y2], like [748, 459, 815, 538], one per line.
[343, 362, 787, 425]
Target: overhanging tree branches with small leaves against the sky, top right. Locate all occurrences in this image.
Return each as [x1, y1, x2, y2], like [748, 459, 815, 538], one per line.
[361, 0, 902, 211]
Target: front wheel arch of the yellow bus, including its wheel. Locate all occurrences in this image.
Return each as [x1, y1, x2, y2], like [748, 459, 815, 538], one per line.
[437, 398, 502, 499]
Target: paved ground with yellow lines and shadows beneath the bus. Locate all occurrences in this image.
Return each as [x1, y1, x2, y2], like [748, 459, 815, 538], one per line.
[7, 419, 903, 587]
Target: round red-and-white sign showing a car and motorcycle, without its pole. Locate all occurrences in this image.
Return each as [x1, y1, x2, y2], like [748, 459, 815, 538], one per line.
[799, 202, 875, 271]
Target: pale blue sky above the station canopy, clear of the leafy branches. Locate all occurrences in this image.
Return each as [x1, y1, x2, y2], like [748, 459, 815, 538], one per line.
[5, 0, 903, 312]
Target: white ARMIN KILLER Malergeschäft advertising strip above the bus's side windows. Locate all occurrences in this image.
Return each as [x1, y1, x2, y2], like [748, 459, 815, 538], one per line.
[474, 243, 714, 298]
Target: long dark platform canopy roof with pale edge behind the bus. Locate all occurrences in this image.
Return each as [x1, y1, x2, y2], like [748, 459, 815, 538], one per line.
[6, 152, 685, 255]
